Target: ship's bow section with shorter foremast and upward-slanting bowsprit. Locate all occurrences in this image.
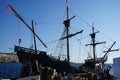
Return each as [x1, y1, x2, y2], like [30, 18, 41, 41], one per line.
[84, 24, 119, 70]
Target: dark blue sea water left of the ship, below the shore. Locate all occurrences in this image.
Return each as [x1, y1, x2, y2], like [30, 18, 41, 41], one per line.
[0, 63, 22, 79]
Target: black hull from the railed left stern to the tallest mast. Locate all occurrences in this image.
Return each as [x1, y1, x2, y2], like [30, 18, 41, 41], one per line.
[15, 46, 71, 73]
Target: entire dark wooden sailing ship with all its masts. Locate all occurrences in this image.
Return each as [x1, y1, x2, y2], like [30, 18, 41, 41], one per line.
[8, 1, 118, 80]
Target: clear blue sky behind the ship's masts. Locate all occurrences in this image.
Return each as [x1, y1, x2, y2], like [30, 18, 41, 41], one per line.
[0, 0, 120, 63]
